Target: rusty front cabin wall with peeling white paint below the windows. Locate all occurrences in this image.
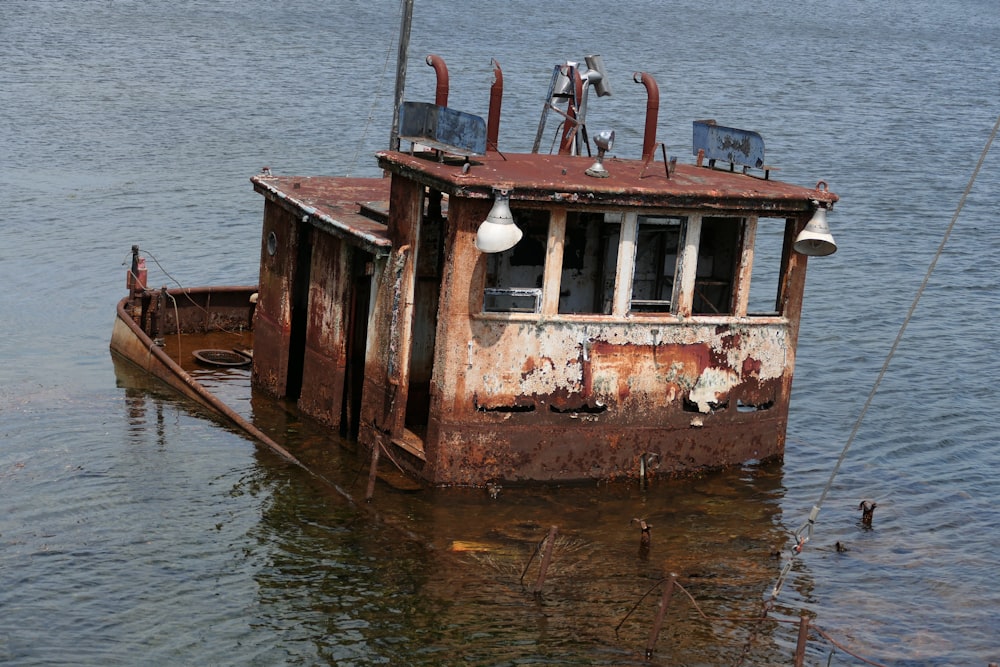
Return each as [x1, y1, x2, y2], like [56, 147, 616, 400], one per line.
[423, 197, 805, 484]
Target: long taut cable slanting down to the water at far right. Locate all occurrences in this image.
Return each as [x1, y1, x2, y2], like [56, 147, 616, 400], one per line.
[771, 111, 1000, 598]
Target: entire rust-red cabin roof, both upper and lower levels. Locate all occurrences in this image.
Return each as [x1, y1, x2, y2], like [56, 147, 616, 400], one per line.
[250, 151, 838, 255]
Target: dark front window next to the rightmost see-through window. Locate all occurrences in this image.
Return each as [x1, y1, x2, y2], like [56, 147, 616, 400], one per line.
[691, 218, 743, 315]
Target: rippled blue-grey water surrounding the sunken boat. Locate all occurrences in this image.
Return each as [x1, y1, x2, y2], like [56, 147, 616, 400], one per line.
[0, 0, 1000, 666]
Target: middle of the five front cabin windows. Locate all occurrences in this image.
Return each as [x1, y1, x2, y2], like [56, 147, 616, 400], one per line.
[630, 215, 684, 313]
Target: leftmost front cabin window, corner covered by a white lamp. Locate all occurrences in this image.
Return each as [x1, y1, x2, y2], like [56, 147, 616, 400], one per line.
[483, 208, 549, 313]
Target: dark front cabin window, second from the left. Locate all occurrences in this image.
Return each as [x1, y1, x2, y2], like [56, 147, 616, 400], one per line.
[559, 211, 622, 315]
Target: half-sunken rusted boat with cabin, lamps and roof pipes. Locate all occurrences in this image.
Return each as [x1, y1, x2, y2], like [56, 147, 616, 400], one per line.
[112, 56, 837, 486]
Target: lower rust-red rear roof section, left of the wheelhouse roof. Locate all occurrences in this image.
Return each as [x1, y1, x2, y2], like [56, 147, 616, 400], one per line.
[250, 175, 392, 255]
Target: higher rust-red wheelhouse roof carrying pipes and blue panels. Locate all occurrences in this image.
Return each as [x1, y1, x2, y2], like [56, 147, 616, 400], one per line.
[378, 151, 838, 213]
